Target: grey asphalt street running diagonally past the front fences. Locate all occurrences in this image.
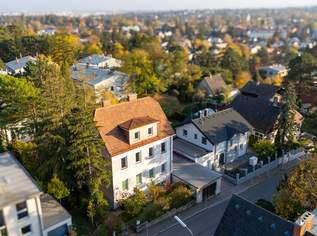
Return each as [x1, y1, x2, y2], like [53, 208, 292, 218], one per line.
[140, 160, 298, 236]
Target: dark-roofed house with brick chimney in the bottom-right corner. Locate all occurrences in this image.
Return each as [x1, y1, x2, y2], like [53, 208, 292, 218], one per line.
[214, 195, 317, 236]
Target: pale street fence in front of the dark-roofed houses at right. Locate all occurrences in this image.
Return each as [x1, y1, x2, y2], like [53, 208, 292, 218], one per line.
[223, 148, 305, 185]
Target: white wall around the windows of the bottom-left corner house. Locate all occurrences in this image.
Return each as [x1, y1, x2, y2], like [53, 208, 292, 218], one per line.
[3, 197, 42, 236]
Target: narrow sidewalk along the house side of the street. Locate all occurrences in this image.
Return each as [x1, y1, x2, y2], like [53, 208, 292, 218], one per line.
[139, 159, 300, 236]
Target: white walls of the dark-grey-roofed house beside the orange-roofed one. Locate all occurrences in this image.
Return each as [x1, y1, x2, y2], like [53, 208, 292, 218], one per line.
[176, 123, 249, 169]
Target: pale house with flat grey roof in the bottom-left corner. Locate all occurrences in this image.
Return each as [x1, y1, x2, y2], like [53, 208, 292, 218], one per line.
[0, 153, 72, 236]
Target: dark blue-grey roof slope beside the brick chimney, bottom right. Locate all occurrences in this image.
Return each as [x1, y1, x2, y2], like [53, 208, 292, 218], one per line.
[214, 195, 294, 236]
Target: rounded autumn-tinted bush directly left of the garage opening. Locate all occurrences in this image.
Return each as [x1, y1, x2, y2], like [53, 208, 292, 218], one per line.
[169, 185, 193, 208]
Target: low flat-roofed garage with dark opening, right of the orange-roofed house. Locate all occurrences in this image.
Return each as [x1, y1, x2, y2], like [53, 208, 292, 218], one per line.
[172, 153, 221, 203]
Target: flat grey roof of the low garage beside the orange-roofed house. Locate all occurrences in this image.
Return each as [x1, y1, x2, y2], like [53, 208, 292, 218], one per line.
[172, 154, 221, 189]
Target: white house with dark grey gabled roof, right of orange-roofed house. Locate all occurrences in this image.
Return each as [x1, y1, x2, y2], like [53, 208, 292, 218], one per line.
[174, 108, 253, 170]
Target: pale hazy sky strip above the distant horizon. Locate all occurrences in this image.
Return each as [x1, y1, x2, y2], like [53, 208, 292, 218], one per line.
[0, 0, 317, 12]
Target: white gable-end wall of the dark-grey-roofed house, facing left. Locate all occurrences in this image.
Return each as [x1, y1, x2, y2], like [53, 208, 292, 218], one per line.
[176, 123, 214, 151]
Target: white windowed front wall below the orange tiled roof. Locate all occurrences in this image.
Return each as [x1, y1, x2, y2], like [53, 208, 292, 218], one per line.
[111, 137, 173, 207]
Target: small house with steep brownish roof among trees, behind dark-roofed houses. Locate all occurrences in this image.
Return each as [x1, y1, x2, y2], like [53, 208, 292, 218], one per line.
[197, 74, 227, 97]
